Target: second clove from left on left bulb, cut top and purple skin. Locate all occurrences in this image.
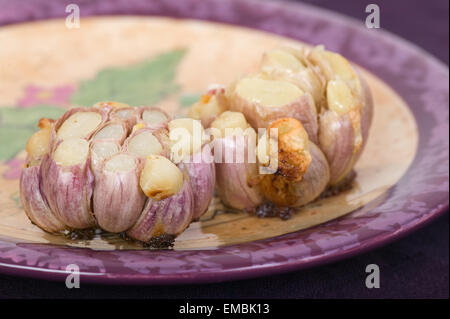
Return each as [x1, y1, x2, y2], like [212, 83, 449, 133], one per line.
[41, 138, 95, 229]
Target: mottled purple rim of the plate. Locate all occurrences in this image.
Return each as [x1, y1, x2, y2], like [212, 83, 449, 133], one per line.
[0, 0, 448, 284]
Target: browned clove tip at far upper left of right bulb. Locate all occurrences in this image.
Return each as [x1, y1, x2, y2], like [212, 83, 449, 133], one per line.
[189, 86, 227, 127]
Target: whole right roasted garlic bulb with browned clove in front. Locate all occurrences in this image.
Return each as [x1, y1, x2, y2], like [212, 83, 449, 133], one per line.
[191, 46, 373, 208]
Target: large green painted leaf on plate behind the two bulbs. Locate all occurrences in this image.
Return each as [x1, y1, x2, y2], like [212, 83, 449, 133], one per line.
[71, 49, 186, 106]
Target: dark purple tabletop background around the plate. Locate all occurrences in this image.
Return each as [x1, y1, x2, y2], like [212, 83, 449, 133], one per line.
[0, 0, 449, 298]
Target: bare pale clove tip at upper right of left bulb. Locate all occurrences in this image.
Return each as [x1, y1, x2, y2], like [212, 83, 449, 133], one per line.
[168, 118, 205, 163]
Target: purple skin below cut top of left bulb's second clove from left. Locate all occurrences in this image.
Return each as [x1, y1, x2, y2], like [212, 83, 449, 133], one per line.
[41, 155, 96, 229]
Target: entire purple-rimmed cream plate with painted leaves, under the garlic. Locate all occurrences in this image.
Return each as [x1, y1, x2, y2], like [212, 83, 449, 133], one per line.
[0, 0, 449, 284]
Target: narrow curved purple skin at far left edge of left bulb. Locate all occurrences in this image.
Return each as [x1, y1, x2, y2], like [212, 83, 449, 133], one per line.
[20, 166, 66, 233]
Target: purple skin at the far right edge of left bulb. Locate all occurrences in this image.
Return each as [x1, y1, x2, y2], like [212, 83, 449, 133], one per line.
[179, 144, 216, 220]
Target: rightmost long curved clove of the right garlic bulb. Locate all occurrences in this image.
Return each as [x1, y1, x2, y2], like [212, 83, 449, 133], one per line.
[307, 47, 373, 186]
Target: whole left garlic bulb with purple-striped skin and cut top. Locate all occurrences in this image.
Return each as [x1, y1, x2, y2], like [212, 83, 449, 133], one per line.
[20, 102, 215, 242]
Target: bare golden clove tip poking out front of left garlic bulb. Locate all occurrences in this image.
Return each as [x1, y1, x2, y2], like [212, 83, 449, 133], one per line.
[139, 155, 184, 200]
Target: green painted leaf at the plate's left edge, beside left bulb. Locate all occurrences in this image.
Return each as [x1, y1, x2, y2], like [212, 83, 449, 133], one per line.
[0, 105, 65, 160]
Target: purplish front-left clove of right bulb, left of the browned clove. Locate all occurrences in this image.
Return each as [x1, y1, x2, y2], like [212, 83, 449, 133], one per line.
[214, 137, 263, 209]
